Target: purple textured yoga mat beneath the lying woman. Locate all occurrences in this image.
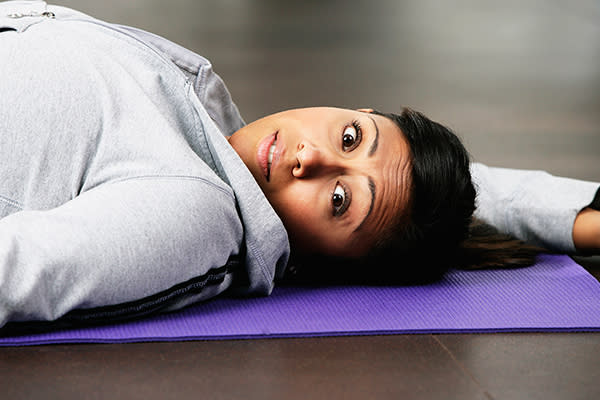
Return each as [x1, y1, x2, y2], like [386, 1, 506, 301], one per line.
[0, 255, 600, 346]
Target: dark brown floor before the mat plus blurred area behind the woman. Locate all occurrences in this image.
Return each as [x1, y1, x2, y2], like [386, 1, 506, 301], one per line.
[0, 0, 600, 400]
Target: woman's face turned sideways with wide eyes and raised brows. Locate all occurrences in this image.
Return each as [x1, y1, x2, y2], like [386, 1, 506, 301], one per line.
[229, 107, 411, 257]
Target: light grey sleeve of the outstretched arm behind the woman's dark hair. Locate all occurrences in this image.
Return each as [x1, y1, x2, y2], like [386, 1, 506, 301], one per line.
[471, 163, 600, 253]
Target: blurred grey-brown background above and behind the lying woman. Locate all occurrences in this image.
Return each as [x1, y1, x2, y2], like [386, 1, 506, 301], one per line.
[53, 0, 600, 180]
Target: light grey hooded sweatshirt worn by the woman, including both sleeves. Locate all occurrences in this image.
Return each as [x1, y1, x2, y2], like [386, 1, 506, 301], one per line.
[0, 1, 598, 327]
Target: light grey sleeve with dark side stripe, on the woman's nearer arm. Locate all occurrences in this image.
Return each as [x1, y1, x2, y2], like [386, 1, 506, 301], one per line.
[0, 177, 243, 327]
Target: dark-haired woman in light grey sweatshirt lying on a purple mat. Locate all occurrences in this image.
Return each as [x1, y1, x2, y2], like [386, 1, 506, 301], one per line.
[0, 1, 600, 326]
